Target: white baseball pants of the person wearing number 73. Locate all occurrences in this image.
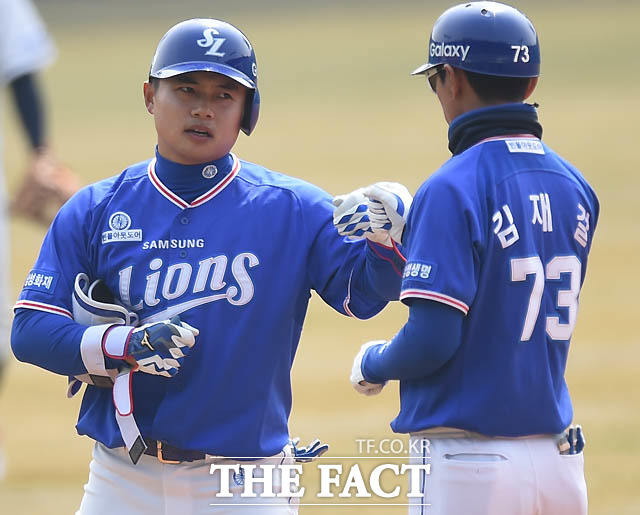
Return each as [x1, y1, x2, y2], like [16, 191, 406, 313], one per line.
[409, 428, 587, 515]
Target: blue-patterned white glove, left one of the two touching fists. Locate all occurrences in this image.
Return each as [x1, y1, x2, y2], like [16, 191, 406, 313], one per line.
[333, 188, 391, 246]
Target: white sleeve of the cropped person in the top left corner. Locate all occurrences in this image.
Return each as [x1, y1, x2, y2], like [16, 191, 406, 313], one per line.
[0, 0, 56, 84]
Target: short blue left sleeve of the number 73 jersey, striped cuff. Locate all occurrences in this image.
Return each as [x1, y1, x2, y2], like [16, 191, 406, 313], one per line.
[400, 175, 482, 315]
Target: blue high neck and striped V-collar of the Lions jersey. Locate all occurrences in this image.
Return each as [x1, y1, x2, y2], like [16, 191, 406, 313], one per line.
[147, 148, 240, 209]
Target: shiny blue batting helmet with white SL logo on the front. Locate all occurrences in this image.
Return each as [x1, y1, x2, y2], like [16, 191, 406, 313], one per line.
[149, 18, 260, 135]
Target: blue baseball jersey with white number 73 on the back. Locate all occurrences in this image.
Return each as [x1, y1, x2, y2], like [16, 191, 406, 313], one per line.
[392, 135, 599, 436]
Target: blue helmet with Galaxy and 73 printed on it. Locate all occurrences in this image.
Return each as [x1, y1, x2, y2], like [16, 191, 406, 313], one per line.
[412, 2, 540, 77]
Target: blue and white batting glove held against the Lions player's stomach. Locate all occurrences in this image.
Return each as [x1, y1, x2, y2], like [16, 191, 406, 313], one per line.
[103, 317, 199, 377]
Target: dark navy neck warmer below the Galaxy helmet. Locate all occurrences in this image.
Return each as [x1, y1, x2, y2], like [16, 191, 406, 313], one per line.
[449, 103, 542, 156]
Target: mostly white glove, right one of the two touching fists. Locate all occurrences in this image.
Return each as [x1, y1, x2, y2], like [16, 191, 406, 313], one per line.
[363, 182, 413, 243]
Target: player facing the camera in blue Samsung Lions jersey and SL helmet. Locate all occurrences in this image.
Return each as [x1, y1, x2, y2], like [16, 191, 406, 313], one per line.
[12, 19, 402, 514]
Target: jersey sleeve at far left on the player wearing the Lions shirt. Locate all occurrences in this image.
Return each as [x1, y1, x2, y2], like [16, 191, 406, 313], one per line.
[14, 183, 95, 318]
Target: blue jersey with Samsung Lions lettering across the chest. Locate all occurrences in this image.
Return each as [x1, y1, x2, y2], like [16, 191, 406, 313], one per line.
[16, 155, 401, 457]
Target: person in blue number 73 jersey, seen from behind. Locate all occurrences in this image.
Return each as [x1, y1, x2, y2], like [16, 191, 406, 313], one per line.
[342, 2, 599, 515]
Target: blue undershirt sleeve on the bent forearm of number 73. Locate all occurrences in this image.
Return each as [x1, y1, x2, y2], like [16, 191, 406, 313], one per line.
[362, 299, 464, 383]
